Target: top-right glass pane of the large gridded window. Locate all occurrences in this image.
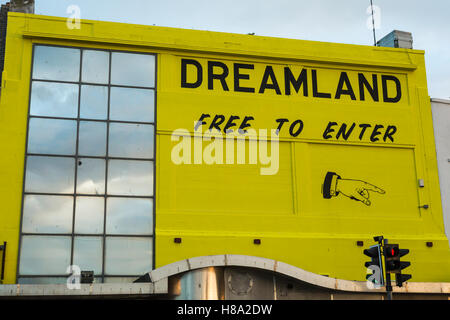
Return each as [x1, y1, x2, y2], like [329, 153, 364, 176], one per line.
[111, 52, 155, 87]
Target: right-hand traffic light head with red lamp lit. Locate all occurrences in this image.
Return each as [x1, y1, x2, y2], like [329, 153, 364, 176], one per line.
[384, 244, 411, 287]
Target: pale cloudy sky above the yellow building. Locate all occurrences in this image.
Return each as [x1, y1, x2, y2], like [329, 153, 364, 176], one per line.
[4, 0, 450, 99]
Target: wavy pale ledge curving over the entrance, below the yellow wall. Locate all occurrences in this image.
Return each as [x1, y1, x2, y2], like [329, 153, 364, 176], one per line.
[149, 254, 450, 294]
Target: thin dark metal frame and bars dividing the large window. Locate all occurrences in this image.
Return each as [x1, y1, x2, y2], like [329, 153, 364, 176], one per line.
[16, 42, 159, 283]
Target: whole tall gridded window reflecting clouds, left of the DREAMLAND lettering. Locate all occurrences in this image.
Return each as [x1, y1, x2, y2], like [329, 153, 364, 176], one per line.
[18, 45, 156, 284]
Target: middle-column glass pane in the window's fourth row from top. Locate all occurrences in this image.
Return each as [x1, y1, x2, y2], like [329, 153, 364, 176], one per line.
[77, 158, 105, 194]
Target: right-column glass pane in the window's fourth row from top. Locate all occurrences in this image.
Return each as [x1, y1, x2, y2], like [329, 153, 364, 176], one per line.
[108, 160, 153, 196]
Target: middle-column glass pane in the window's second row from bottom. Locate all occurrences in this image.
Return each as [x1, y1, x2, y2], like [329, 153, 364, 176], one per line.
[75, 197, 105, 234]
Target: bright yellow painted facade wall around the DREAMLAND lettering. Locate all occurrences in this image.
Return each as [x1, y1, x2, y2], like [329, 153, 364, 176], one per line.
[0, 13, 450, 283]
